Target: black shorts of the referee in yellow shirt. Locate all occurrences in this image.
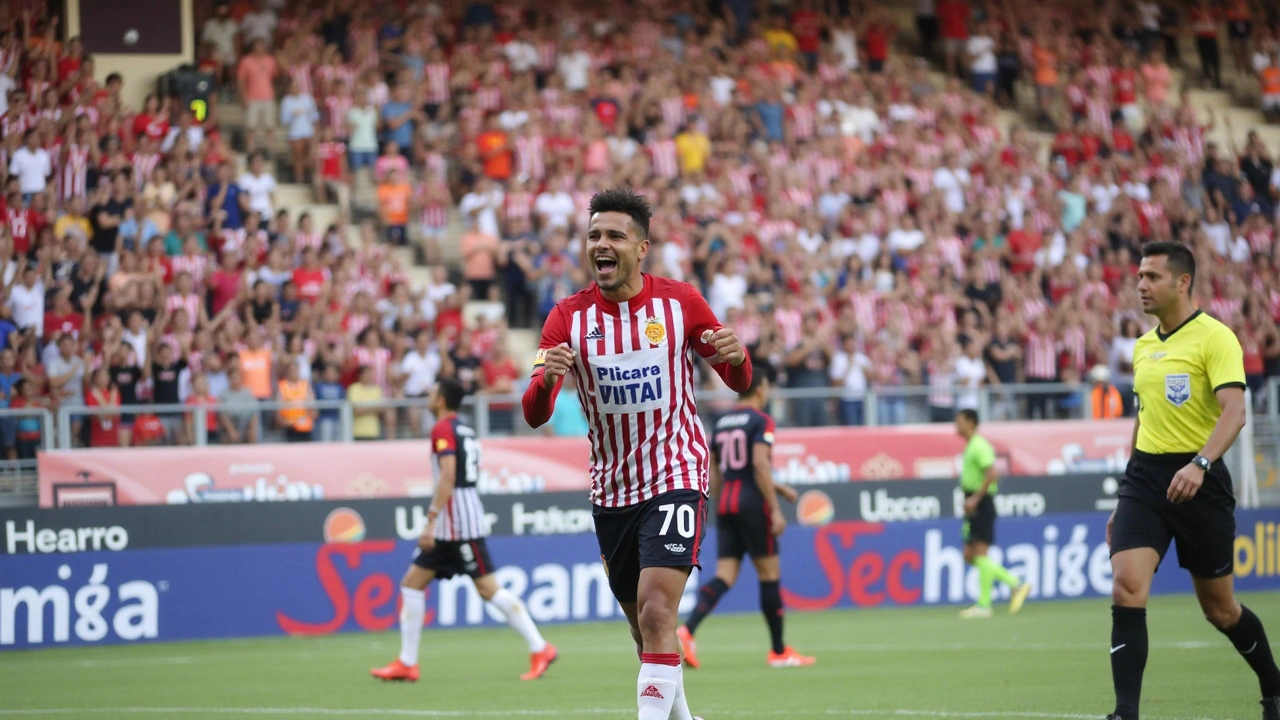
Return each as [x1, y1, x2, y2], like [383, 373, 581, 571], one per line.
[1111, 451, 1235, 579]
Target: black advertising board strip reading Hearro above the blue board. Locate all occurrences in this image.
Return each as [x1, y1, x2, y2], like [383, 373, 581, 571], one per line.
[0, 475, 1116, 556]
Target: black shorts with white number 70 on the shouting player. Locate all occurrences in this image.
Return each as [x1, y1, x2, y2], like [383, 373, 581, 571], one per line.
[591, 489, 707, 602]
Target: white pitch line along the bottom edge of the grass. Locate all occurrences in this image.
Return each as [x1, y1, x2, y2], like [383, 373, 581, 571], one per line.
[0, 707, 1239, 720]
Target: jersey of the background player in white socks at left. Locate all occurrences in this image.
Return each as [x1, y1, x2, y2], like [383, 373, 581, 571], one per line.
[431, 415, 489, 542]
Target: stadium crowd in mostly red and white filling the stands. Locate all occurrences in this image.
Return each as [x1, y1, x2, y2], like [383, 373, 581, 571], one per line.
[0, 0, 1280, 448]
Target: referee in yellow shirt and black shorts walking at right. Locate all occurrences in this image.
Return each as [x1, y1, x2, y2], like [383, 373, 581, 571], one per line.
[1107, 242, 1280, 720]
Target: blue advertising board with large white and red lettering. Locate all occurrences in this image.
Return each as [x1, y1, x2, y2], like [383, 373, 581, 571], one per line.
[0, 511, 1280, 650]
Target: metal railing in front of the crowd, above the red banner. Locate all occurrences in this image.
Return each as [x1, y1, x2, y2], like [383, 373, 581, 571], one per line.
[0, 378, 1280, 506]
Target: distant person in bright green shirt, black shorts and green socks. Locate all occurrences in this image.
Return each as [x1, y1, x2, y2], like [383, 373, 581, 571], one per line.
[956, 410, 1032, 619]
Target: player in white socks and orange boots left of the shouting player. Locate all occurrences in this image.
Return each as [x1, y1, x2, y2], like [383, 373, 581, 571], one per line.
[370, 378, 556, 680]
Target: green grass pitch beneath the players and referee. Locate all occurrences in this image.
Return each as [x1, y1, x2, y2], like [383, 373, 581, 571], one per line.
[0, 587, 1280, 720]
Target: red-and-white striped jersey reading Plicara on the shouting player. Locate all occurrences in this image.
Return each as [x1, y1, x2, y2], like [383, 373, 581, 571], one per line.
[524, 274, 751, 507]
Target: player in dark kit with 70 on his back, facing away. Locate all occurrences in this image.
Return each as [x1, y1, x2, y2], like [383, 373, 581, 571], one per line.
[676, 365, 814, 667]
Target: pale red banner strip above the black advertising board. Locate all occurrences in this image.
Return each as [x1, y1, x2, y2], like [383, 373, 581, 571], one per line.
[40, 420, 1133, 507]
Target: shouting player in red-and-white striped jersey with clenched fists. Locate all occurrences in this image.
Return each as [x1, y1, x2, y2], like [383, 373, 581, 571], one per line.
[524, 188, 751, 720]
